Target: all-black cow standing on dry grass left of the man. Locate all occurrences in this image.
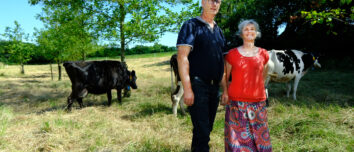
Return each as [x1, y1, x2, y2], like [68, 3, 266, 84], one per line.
[63, 61, 137, 110]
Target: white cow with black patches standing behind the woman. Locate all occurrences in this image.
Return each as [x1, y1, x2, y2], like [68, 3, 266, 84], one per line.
[265, 50, 321, 100]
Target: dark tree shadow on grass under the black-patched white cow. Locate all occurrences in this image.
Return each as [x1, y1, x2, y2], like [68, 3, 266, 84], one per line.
[268, 70, 354, 108]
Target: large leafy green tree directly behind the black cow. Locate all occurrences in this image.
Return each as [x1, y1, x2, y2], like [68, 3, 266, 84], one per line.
[29, 0, 199, 62]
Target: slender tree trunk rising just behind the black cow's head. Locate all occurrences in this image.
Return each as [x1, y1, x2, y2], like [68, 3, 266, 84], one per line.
[119, 3, 125, 63]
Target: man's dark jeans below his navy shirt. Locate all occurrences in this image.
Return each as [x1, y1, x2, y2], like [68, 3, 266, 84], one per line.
[188, 77, 219, 152]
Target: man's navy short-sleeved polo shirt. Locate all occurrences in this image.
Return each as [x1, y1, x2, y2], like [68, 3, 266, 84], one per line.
[177, 16, 226, 82]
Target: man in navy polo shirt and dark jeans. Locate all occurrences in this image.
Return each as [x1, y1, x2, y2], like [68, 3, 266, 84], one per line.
[177, 0, 226, 152]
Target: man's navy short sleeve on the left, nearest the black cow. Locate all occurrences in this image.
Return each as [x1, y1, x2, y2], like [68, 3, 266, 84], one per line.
[177, 20, 195, 48]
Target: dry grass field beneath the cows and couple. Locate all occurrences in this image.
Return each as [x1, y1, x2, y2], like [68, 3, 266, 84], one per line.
[0, 53, 354, 152]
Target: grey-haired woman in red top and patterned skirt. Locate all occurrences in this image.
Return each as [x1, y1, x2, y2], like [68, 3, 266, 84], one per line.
[222, 20, 272, 152]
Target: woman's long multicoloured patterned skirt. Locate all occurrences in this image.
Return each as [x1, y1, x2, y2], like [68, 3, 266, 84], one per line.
[225, 101, 272, 152]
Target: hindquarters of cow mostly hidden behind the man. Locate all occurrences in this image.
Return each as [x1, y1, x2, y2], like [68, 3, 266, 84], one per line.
[170, 54, 186, 116]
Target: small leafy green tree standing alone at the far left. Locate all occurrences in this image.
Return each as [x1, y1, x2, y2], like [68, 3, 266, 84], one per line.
[3, 21, 33, 74]
